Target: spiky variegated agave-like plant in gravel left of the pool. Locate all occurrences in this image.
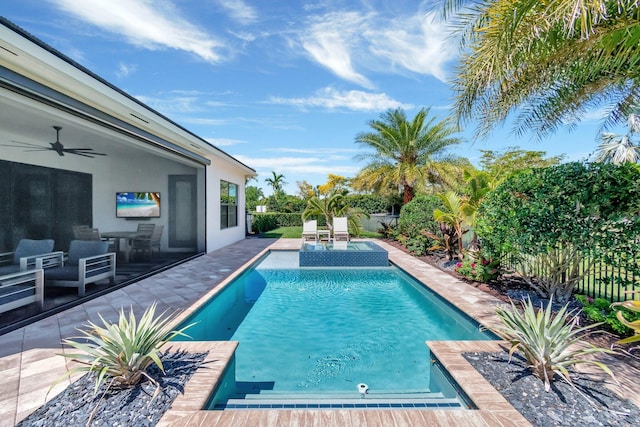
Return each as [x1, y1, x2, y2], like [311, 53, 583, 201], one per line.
[51, 302, 192, 393]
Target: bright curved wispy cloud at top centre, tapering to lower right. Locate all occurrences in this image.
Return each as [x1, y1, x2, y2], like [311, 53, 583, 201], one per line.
[301, 12, 373, 88]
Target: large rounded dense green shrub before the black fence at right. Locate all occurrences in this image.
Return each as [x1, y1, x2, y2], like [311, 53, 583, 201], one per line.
[476, 163, 640, 303]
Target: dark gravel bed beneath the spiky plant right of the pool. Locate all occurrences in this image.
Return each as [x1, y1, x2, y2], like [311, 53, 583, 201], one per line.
[463, 353, 640, 427]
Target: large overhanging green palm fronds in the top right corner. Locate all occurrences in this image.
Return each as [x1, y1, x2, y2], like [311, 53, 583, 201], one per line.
[444, 0, 640, 137]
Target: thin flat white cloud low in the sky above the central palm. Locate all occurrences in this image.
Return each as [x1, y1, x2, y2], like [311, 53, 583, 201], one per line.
[269, 87, 413, 111]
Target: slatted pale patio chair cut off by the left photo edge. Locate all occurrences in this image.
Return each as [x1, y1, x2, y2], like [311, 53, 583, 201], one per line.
[0, 269, 44, 313]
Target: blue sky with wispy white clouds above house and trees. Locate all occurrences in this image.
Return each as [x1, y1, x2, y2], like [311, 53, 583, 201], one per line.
[0, 0, 599, 195]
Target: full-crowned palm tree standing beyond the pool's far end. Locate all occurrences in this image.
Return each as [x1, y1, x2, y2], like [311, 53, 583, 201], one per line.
[352, 108, 461, 204]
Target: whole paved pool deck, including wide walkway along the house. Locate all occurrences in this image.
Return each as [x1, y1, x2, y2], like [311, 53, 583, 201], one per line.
[0, 239, 640, 427]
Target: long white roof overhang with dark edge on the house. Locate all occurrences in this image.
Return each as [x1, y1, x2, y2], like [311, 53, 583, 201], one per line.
[0, 17, 256, 176]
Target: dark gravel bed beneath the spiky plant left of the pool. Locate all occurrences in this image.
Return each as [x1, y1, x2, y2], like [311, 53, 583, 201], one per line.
[18, 352, 206, 427]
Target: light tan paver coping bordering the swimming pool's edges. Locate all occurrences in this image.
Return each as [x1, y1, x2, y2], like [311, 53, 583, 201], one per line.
[158, 239, 531, 426]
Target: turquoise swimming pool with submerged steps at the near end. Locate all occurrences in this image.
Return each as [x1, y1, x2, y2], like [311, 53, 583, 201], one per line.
[174, 251, 496, 409]
